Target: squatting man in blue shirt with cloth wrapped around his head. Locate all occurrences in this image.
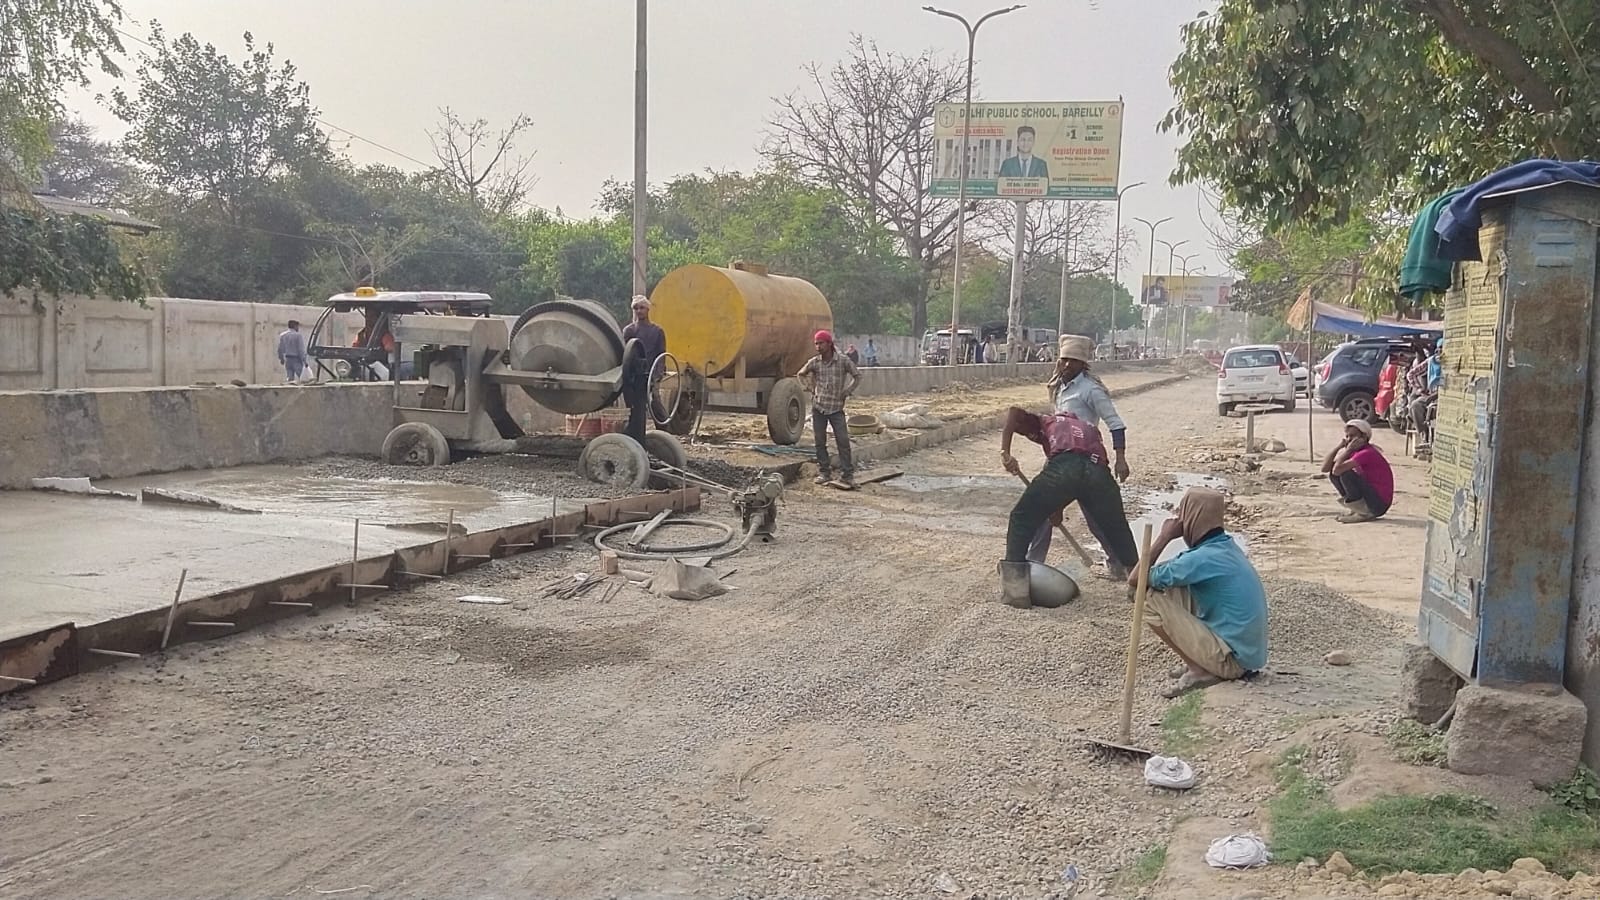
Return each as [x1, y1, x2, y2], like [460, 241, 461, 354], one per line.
[1128, 487, 1267, 697]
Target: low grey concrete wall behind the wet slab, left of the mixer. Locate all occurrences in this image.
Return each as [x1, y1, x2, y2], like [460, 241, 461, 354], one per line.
[0, 379, 394, 488]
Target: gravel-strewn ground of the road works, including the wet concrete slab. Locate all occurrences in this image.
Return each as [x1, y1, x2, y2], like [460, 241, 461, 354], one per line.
[0, 370, 1497, 898]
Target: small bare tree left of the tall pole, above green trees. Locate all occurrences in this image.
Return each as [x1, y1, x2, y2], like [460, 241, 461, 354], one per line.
[427, 106, 538, 216]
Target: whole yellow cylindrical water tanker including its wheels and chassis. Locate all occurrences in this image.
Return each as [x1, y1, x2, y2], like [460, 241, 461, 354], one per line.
[650, 263, 834, 444]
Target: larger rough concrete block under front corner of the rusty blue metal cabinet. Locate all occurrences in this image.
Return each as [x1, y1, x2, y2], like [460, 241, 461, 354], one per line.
[1445, 684, 1589, 788]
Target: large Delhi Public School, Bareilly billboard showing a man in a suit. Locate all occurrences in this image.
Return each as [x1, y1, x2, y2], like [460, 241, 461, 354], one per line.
[930, 101, 1122, 200]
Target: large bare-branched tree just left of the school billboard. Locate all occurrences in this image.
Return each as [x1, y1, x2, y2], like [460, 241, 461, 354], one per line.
[762, 34, 966, 335]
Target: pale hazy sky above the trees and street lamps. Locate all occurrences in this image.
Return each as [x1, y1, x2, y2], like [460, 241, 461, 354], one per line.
[69, 0, 1226, 285]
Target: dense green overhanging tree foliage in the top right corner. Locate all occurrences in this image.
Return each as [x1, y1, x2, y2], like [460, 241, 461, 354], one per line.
[1162, 0, 1600, 227]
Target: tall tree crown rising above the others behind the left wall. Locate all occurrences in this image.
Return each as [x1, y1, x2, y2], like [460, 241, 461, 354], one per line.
[110, 22, 328, 216]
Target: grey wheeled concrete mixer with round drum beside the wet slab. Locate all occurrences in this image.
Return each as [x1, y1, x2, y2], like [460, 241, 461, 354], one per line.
[371, 295, 688, 488]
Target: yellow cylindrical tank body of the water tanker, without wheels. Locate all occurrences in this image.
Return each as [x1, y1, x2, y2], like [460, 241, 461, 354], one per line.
[650, 263, 834, 378]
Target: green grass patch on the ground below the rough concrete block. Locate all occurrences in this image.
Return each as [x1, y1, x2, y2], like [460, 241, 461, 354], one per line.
[1270, 748, 1600, 876]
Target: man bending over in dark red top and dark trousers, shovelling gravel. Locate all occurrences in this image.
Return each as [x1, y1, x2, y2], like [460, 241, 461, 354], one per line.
[1000, 407, 1139, 605]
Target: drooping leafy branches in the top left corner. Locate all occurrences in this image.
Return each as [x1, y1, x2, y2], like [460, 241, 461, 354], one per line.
[0, 0, 122, 176]
